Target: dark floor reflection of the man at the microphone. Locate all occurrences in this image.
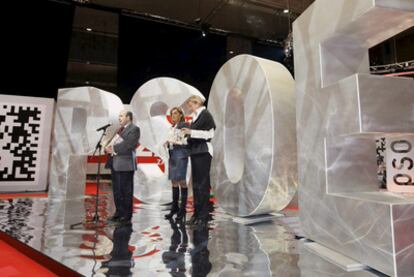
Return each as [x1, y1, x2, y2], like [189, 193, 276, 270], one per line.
[101, 223, 134, 276]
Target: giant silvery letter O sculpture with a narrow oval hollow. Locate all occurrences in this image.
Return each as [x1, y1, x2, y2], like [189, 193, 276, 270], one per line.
[208, 55, 297, 216]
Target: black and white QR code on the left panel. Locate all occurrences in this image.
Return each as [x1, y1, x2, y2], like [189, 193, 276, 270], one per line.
[0, 103, 42, 182]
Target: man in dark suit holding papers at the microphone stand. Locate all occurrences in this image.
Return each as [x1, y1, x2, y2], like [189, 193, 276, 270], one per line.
[105, 111, 140, 222]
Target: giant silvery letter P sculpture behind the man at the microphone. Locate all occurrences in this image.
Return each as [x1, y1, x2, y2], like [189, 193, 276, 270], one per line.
[49, 87, 123, 200]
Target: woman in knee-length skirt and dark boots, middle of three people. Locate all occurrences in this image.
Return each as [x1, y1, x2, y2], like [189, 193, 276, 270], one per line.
[165, 107, 189, 221]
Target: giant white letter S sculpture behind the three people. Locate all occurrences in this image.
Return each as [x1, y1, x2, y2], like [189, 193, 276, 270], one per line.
[131, 77, 204, 204]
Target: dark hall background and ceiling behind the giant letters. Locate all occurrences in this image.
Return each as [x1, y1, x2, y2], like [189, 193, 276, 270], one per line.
[0, 0, 414, 103]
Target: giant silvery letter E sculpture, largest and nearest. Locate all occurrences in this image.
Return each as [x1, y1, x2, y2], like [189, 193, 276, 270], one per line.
[293, 0, 414, 276]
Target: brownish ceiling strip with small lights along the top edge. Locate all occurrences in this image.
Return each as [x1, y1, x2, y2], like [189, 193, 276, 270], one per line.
[73, 0, 314, 41]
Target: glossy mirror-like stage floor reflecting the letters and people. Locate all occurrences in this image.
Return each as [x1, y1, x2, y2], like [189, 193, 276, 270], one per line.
[0, 183, 386, 277]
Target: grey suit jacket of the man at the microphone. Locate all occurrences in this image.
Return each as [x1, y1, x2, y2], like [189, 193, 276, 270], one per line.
[105, 123, 140, 171]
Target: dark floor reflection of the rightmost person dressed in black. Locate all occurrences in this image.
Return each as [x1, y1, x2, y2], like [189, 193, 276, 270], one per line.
[190, 224, 212, 277]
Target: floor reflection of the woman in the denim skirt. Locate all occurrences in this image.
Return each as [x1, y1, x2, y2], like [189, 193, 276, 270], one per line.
[162, 219, 188, 277]
